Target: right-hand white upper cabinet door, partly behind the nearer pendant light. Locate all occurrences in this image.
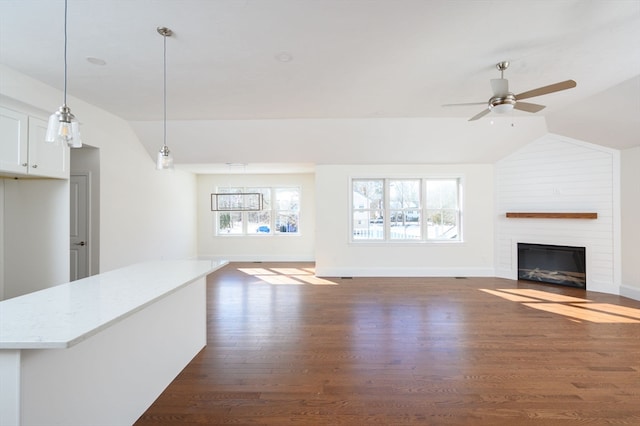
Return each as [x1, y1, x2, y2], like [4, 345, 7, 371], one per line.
[27, 117, 69, 179]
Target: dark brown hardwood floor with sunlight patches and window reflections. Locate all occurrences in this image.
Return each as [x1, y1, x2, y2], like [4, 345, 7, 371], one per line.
[136, 263, 640, 426]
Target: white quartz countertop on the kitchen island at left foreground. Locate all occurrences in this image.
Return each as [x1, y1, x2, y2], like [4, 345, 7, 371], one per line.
[0, 260, 227, 349]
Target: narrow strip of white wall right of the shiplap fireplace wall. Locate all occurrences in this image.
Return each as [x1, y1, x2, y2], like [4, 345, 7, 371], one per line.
[620, 146, 640, 300]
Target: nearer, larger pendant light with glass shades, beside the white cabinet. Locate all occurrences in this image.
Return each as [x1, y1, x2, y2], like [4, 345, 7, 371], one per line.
[45, 0, 82, 148]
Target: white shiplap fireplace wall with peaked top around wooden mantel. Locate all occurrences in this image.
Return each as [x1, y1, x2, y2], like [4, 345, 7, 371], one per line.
[495, 134, 620, 294]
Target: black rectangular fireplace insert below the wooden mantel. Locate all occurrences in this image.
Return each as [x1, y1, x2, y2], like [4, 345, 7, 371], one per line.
[518, 243, 587, 288]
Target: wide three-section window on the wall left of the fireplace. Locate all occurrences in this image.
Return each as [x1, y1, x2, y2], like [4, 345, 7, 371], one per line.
[351, 178, 461, 242]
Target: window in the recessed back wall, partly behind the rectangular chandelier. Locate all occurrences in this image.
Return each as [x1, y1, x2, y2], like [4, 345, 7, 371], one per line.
[215, 187, 300, 236]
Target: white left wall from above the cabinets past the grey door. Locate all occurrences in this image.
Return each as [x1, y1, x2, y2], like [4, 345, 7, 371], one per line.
[0, 65, 197, 271]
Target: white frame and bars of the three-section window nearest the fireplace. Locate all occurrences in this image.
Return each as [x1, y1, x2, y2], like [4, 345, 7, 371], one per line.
[348, 174, 464, 245]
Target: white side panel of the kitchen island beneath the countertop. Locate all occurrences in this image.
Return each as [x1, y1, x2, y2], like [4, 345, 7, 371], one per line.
[21, 277, 206, 426]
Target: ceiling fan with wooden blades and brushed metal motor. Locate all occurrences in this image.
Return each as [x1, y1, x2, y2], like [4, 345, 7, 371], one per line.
[442, 61, 576, 121]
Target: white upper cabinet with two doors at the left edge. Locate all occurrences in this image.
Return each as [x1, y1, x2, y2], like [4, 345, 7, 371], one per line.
[0, 107, 69, 179]
